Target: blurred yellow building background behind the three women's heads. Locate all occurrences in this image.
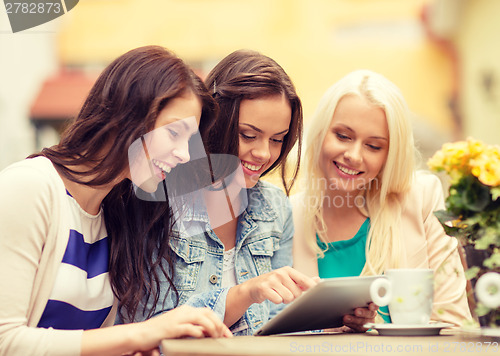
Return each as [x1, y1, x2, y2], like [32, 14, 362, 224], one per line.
[0, 0, 500, 175]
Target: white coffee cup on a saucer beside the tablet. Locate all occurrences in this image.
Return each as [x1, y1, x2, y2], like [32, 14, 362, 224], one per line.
[370, 269, 434, 325]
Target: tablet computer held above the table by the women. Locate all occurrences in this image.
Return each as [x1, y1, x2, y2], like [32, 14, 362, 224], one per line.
[255, 276, 386, 335]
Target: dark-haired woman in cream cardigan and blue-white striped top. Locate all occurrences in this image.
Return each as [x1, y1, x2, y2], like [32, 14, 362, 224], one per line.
[0, 46, 230, 355]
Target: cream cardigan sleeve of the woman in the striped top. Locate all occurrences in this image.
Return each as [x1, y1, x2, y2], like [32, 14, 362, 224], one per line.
[0, 161, 82, 356]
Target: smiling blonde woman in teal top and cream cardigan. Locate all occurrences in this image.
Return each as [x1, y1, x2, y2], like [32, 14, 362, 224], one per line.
[292, 70, 471, 325]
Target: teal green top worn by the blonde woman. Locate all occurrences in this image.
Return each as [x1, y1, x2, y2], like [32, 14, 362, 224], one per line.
[316, 218, 391, 323]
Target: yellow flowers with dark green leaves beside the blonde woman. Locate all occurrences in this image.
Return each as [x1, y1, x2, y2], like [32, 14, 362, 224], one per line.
[427, 138, 500, 272]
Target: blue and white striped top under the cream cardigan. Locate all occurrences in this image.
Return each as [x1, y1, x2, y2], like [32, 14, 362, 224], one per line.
[38, 192, 114, 330]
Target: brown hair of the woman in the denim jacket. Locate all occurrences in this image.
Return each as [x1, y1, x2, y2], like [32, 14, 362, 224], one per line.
[205, 50, 303, 195]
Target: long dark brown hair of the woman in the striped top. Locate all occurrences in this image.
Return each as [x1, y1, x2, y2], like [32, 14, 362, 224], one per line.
[31, 46, 216, 320]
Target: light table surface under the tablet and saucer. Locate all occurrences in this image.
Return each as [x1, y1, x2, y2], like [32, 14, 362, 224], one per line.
[161, 330, 500, 356]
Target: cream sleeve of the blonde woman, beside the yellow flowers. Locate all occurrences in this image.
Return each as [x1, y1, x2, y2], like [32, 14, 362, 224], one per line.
[417, 174, 472, 325]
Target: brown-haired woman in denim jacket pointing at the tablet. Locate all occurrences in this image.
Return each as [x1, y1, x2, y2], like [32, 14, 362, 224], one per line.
[200, 50, 316, 334]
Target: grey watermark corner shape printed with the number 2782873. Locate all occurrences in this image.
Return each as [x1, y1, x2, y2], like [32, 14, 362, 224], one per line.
[4, 0, 79, 33]
